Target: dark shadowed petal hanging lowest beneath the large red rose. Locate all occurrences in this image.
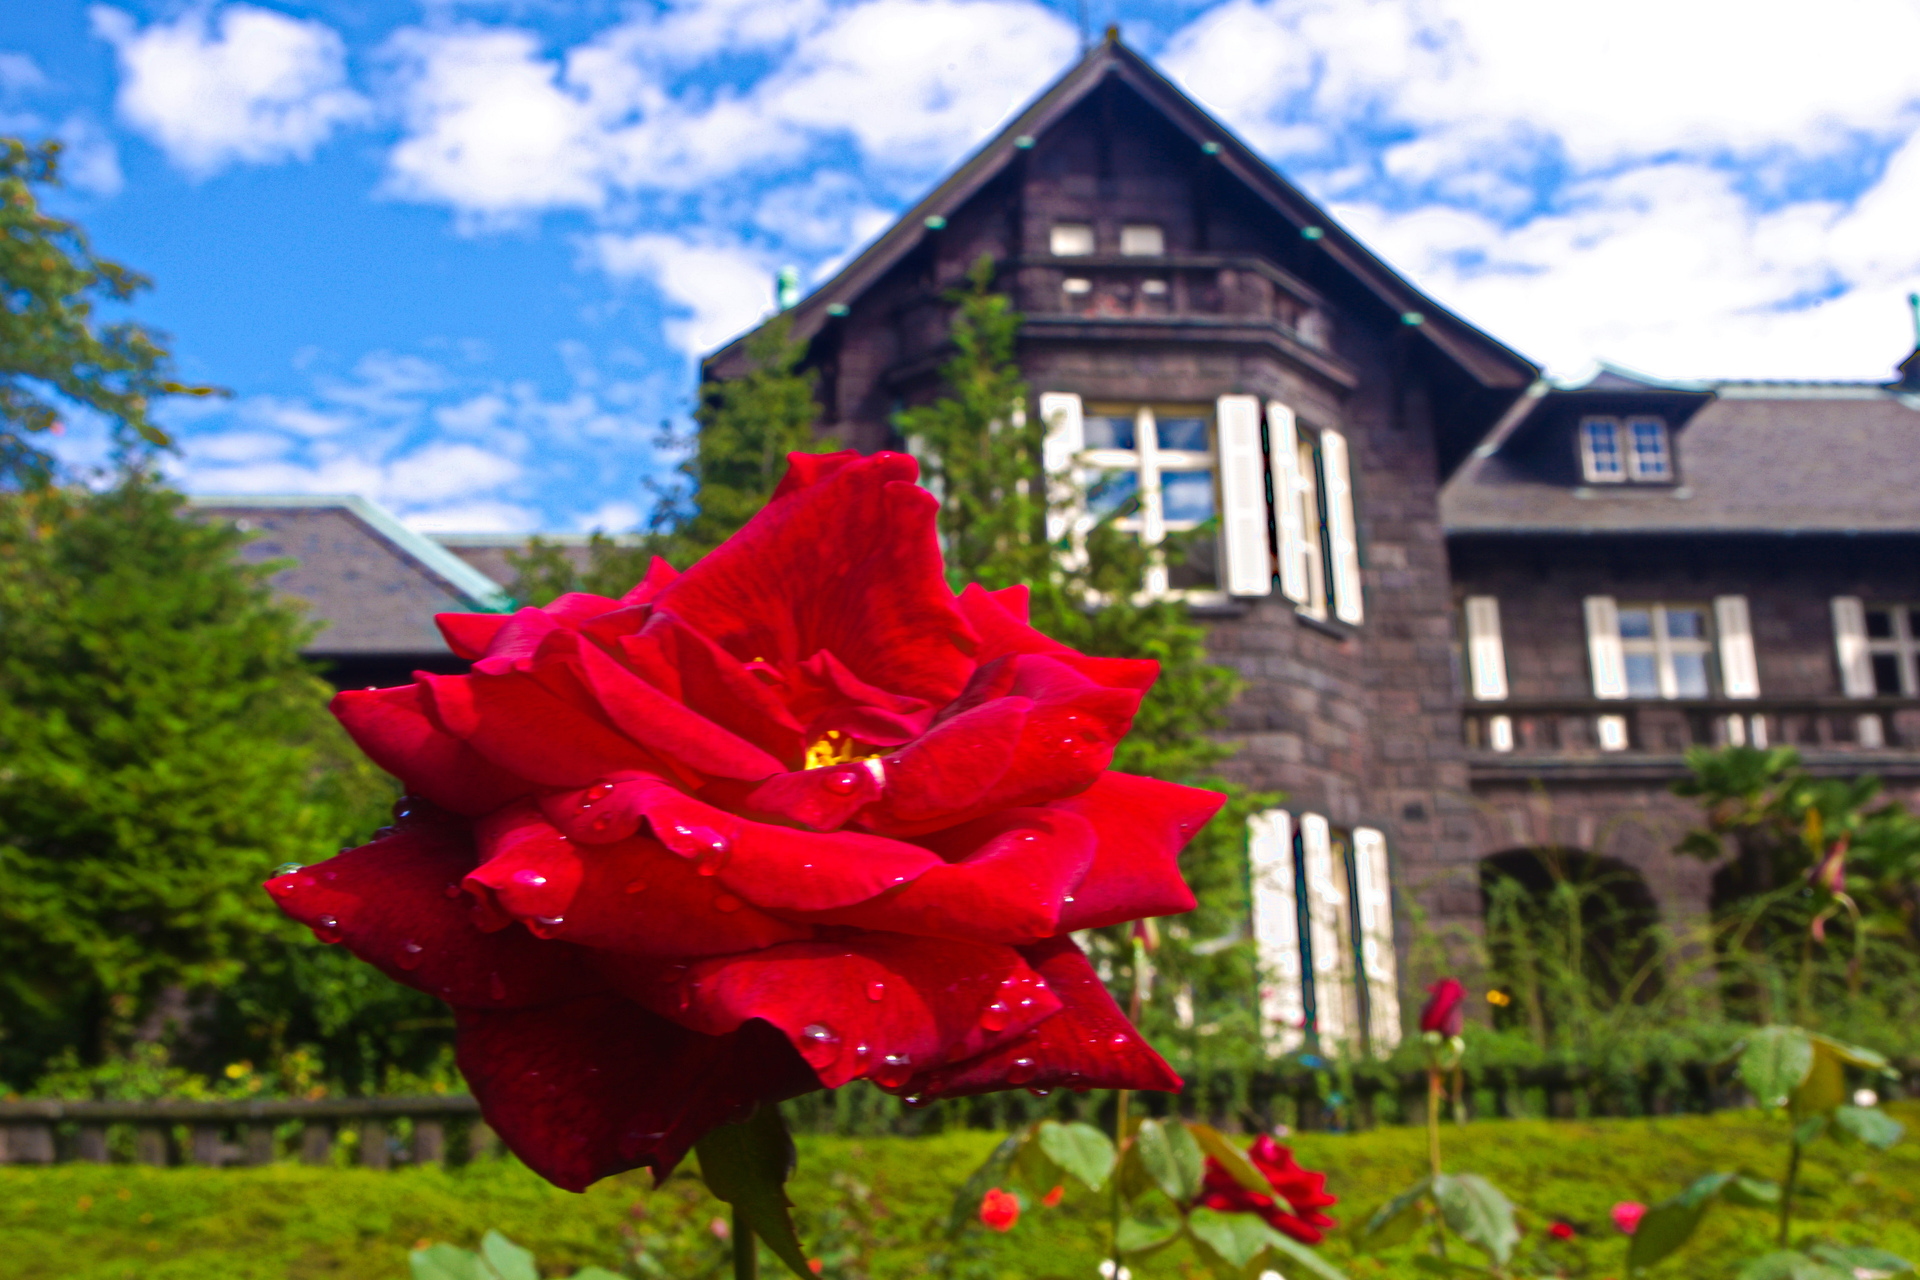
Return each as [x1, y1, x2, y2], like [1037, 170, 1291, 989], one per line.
[455, 996, 818, 1192]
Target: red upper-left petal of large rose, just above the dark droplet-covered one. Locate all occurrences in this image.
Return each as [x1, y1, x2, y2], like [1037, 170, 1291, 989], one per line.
[328, 685, 532, 814]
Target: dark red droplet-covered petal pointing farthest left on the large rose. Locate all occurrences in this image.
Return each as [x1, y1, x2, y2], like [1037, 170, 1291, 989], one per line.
[267, 823, 605, 1009]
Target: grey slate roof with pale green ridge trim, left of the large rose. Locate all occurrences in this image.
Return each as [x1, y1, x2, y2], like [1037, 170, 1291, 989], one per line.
[188, 493, 511, 658]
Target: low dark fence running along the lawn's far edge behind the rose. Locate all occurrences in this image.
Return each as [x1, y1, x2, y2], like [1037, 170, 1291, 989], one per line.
[0, 1061, 1920, 1169]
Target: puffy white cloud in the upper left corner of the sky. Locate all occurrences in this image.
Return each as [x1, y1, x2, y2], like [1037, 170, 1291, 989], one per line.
[88, 4, 369, 178]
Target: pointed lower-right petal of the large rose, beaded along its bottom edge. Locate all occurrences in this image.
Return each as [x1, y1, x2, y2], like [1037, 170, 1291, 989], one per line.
[908, 938, 1181, 1098]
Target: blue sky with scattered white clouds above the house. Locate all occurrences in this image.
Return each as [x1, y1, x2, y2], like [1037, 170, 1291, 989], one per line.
[0, 0, 1920, 532]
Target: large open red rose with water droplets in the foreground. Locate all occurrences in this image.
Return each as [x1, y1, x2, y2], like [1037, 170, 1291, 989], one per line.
[267, 453, 1221, 1190]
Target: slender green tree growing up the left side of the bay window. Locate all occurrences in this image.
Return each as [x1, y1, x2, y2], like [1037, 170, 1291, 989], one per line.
[897, 257, 1277, 1067]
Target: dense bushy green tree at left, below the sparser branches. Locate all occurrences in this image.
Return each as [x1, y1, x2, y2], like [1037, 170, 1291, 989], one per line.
[0, 470, 420, 1086]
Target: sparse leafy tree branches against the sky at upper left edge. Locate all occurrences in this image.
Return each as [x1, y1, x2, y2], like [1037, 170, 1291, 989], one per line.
[0, 138, 217, 486]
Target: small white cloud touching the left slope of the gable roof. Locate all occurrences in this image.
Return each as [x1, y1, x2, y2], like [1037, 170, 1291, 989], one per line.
[586, 232, 776, 355]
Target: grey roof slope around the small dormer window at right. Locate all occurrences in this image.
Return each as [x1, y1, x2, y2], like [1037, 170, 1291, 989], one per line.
[1440, 382, 1920, 535]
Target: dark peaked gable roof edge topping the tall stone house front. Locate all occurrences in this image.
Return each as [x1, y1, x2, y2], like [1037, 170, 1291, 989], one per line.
[703, 31, 1540, 391]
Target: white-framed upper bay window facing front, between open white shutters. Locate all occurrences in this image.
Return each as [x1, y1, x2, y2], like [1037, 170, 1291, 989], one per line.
[1081, 403, 1219, 595]
